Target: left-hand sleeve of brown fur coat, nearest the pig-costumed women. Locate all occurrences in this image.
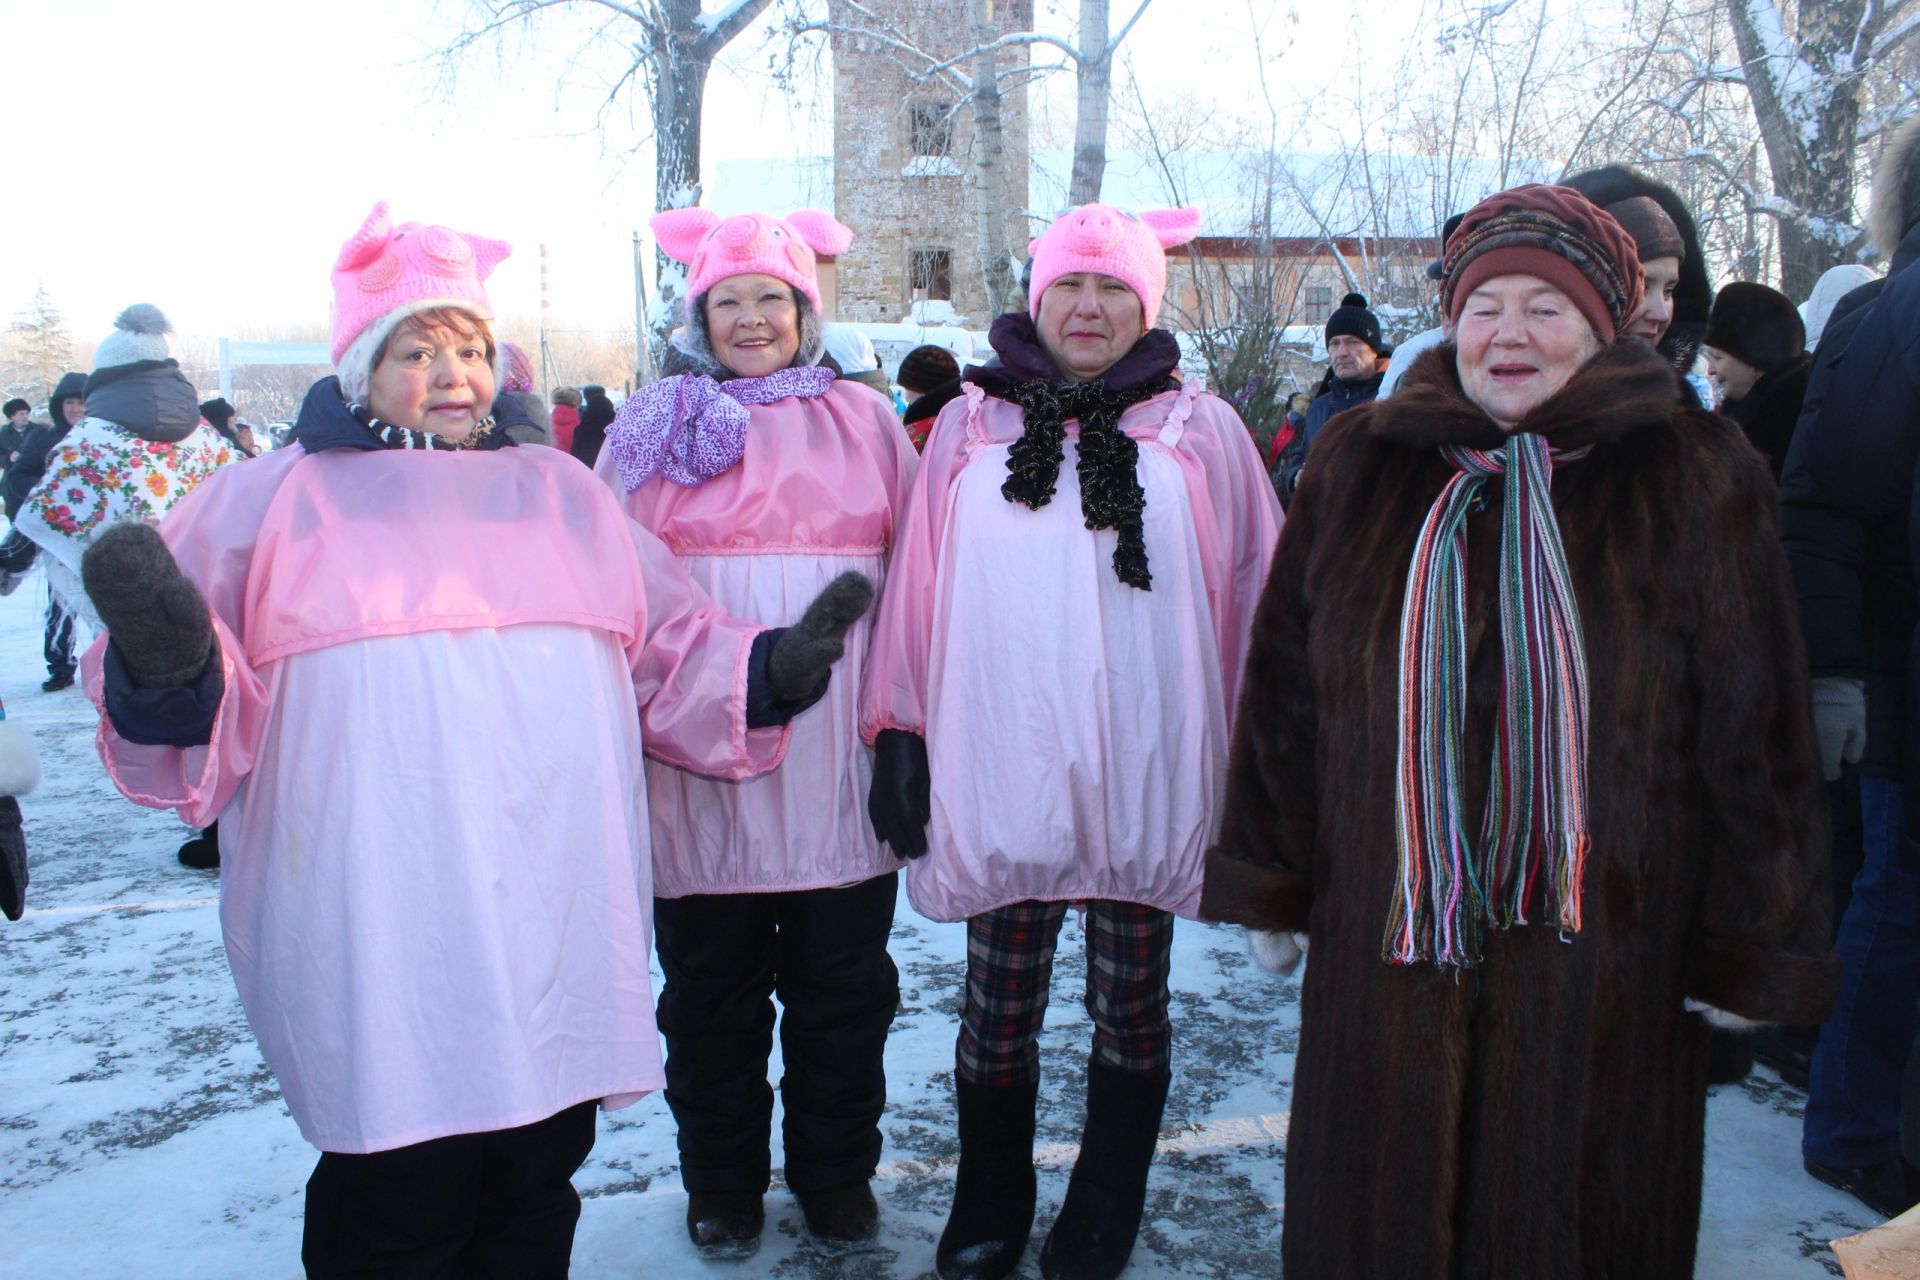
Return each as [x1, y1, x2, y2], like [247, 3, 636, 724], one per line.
[1200, 433, 1331, 929]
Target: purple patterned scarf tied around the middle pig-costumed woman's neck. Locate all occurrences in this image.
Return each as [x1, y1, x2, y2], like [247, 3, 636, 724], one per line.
[607, 365, 833, 493]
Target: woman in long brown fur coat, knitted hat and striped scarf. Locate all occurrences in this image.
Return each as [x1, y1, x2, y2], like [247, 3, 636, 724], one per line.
[1200, 184, 1837, 1280]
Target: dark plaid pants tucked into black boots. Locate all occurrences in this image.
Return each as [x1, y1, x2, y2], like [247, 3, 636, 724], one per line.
[954, 902, 1173, 1088]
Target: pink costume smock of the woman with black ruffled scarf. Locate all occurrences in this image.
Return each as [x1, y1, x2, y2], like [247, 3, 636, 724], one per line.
[860, 384, 1281, 919]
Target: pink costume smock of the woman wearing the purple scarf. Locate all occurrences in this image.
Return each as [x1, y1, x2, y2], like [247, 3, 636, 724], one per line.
[597, 382, 918, 898]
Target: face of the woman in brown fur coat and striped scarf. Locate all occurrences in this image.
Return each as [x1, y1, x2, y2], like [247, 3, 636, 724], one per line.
[1453, 274, 1601, 430]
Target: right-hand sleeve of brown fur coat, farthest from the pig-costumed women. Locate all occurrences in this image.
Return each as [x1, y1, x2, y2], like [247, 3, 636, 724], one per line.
[1674, 415, 1839, 1025]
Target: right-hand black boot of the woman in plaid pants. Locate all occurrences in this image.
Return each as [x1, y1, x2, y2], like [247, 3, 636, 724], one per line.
[1041, 1063, 1171, 1280]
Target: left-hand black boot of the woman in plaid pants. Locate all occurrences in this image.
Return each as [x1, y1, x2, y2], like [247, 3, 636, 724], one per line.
[933, 1080, 1041, 1280]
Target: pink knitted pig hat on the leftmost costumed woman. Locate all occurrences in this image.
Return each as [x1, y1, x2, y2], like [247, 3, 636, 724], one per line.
[332, 200, 513, 401]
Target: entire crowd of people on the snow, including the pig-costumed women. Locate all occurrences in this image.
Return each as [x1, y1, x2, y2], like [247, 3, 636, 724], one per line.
[0, 115, 1920, 1280]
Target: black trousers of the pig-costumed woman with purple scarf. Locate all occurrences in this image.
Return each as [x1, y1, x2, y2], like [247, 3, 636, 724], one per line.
[653, 871, 900, 1192]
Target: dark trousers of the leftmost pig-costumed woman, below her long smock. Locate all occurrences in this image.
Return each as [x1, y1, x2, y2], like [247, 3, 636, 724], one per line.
[300, 1102, 599, 1280]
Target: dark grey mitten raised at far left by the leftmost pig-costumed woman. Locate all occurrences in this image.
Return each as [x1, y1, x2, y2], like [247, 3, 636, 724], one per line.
[81, 520, 213, 689]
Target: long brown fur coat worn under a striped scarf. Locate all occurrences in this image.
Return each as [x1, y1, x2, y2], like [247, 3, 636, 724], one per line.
[1202, 342, 1837, 1280]
